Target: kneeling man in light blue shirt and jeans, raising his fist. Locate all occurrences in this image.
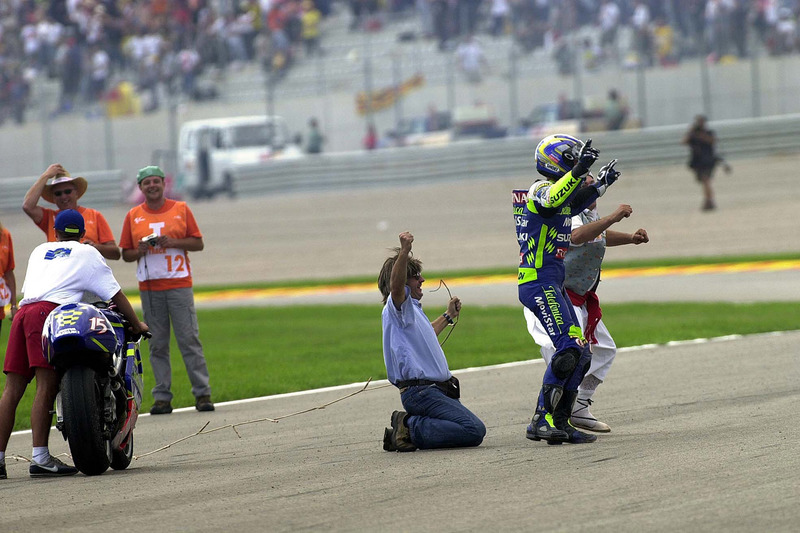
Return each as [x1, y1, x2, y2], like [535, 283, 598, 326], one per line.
[378, 231, 486, 452]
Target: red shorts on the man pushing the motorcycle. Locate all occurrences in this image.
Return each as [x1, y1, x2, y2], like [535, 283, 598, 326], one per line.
[3, 302, 58, 381]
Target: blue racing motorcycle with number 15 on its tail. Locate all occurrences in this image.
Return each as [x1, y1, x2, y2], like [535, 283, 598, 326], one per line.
[42, 302, 150, 476]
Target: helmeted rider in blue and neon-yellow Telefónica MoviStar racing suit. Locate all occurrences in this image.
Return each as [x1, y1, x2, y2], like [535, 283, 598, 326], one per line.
[515, 135, 619, 444]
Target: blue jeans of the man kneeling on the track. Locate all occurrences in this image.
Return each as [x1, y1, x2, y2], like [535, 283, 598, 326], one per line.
[400, 385, 486, 450]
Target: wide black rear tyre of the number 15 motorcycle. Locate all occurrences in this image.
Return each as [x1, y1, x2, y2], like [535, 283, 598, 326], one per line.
[61, 366, 111, 476]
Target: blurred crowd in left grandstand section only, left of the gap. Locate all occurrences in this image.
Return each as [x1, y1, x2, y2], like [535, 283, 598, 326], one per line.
[0, 0, 330, 122]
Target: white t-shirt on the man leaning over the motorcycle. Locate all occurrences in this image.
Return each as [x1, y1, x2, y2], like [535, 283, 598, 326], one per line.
[20, 241, 120, 306]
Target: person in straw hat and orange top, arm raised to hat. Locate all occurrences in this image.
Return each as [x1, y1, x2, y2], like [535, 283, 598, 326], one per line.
[22, 163, 120, 260]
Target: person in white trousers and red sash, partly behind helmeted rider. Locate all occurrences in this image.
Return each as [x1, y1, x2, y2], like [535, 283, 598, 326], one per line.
[523, 174, 650, 433]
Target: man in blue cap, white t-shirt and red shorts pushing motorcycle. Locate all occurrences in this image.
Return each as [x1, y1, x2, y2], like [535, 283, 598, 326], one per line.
[0, 209, 149, 479]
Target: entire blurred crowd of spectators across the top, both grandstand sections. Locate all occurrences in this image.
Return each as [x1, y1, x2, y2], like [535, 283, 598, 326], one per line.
[0, 0, 800, 123]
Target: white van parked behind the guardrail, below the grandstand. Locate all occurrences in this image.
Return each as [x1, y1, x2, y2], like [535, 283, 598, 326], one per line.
[177, 115, 303, 198]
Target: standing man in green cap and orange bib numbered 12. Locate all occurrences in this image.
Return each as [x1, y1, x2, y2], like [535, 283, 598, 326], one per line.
[120, 166, 214, 415]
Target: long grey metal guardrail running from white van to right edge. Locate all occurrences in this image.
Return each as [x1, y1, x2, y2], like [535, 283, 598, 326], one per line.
[230, 115, 800, 196]
